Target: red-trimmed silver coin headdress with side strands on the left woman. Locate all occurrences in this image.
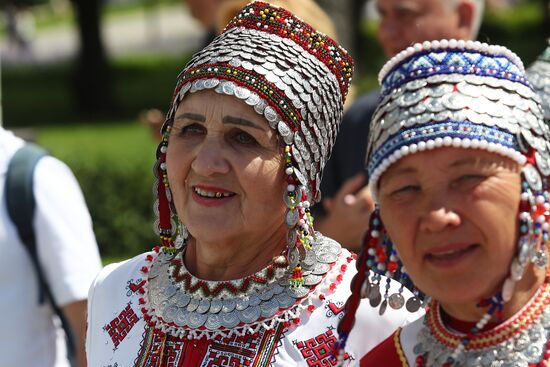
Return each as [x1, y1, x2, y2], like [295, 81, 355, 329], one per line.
[155, 2, 353, 286]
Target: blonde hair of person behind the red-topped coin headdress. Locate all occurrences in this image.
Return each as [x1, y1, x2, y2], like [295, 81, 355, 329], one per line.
[216, 0, 338, 41]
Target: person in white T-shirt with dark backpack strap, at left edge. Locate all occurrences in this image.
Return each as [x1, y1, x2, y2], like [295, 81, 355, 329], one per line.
[0, 126, 101, 367]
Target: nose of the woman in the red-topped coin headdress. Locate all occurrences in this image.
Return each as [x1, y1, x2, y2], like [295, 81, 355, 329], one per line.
[191, 138, 230, 176]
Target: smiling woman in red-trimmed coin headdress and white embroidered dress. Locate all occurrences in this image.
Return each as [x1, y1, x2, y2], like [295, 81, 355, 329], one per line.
[87, 2, 415, 367]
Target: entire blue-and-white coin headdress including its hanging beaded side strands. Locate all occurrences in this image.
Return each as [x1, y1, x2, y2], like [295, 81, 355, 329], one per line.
[339, 40, 550, 366]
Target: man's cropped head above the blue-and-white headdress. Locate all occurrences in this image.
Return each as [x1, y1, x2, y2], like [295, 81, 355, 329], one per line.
[376, 0, 484, 57]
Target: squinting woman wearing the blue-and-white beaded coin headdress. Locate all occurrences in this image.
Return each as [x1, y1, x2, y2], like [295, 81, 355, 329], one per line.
[340, 40, 550, 367]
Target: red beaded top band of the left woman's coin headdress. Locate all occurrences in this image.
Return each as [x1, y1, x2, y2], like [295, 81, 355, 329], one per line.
[224, 1, 353, 103]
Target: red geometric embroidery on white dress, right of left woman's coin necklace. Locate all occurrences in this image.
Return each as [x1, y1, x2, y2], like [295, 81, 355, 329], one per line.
[294, 328, 349, 367]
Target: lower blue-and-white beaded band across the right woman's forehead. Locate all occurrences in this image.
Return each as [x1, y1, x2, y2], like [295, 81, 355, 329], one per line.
[367, 120, 527, 199]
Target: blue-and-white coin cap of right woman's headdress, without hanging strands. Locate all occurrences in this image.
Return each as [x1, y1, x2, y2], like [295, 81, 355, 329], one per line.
[367, 40, 550, 197]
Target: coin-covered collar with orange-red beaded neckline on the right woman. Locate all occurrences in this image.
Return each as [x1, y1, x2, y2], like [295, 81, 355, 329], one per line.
[413, 283, 550, 367]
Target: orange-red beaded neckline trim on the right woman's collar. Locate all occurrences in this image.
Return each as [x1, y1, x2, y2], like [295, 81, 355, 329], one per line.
[426, 283, 550, 350]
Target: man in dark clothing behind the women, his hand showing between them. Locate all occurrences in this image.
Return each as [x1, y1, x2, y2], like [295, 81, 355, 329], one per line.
[313, 0, 484, 250]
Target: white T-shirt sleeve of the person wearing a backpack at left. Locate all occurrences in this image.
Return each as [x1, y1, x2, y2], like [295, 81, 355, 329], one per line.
[34, 156, 101, 306]
